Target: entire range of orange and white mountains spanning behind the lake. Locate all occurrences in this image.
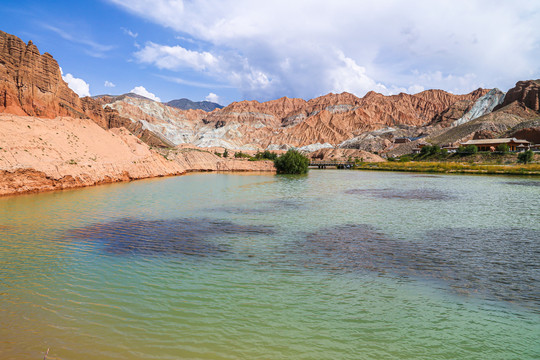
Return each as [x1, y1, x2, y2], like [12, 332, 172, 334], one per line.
[0, 31, 540, 193]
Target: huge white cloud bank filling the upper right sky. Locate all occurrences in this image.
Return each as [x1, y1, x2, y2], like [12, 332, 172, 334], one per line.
[109, 0, 540, 98]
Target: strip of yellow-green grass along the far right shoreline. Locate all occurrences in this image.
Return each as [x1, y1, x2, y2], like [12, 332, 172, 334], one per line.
[356, 161, 540, 176]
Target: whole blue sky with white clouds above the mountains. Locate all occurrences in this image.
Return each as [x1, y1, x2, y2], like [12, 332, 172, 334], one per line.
[0, 0, 540, 105]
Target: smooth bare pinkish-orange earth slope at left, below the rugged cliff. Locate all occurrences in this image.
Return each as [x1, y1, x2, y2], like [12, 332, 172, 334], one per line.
[0, 114, 273, 195]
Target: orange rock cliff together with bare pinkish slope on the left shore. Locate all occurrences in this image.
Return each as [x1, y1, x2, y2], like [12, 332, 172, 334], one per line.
[0, 32, 273, 196]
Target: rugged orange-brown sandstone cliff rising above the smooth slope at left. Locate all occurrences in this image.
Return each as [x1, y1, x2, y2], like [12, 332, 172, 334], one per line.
[0, 31, 171, 146]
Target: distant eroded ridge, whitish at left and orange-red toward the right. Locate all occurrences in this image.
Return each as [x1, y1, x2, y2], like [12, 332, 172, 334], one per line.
[97, 89, 488, 151]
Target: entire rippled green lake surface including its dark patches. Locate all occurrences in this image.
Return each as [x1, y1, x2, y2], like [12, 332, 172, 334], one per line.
[0, 170, 540, 360]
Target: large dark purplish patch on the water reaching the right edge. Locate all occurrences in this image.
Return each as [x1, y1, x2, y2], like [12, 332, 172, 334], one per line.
[297, 225, 540, 307]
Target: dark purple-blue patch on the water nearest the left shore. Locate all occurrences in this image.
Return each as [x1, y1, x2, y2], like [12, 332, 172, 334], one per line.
[68, 218, 274, 256]
